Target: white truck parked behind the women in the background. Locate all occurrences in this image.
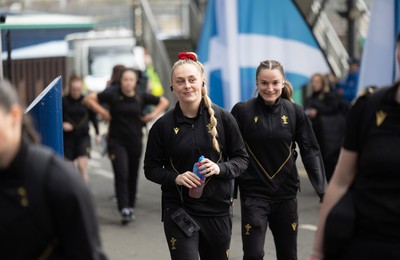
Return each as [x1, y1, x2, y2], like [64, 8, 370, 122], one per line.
[65, 30, 146, 92]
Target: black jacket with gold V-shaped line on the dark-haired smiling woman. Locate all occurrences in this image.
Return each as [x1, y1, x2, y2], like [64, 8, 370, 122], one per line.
[232, 96, 326, 200]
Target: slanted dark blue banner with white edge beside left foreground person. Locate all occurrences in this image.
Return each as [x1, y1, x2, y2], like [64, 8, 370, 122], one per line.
[25, 76, 64, 157]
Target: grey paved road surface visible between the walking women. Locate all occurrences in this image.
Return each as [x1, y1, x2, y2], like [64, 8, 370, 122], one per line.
[89, 133, 319, 260]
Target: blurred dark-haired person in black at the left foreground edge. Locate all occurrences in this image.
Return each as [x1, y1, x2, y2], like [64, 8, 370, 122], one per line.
[0, 81, 106, 260]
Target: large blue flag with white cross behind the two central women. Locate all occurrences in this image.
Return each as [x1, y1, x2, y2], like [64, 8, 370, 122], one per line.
[197, 0, 330, 109]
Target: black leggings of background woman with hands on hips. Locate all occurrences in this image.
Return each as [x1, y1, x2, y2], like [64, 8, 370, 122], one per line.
[108, 141, 142, 210]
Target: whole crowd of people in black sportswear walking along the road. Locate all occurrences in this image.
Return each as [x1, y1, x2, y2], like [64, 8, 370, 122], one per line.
[0, 30, 400, 260]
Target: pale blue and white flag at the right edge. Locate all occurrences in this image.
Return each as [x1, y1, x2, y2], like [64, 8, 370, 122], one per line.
[358, 0, 400, 90]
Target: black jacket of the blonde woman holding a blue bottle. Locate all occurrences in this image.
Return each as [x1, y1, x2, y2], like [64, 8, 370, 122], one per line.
[144, 100, 248, 216]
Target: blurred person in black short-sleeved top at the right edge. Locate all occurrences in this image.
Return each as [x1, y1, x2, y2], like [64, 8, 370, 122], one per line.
[309, 34, 400, 260]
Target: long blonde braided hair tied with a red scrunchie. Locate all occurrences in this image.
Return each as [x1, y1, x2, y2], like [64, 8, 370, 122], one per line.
[171, 52, 220, 152]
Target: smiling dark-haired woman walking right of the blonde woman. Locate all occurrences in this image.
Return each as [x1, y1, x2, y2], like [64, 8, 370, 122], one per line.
[232, 60, 326, 260]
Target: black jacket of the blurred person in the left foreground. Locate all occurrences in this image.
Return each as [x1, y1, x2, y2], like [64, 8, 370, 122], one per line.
[0, 139, 106, 260]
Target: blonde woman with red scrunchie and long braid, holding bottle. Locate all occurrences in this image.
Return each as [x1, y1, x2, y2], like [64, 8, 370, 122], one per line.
[144, 52, 248, 260]
